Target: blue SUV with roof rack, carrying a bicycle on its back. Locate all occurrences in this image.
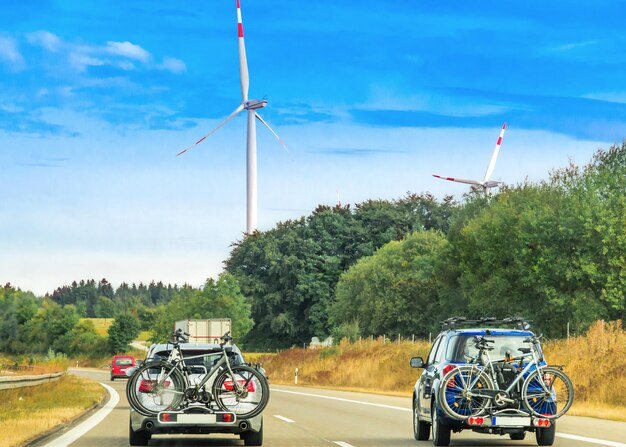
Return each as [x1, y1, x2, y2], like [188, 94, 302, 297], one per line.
[410, 317, 556, 446]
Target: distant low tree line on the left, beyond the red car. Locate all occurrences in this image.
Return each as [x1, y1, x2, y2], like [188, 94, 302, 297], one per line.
[0, 274, 253, 358]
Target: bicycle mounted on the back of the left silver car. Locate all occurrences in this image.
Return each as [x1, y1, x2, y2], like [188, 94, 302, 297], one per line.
[126, 329, 269, 418]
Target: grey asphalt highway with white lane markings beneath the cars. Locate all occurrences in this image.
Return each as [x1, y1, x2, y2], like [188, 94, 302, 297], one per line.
[33, 370, 626, 447]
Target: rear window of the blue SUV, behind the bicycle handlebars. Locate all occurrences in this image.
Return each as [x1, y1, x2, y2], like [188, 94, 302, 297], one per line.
[446, 334, 530, 363]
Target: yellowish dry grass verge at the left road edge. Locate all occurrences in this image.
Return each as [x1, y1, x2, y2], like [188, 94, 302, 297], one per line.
[0, 375, 106, 447]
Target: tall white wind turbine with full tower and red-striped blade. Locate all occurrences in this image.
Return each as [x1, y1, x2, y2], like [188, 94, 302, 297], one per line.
[176, 0, 287, 234]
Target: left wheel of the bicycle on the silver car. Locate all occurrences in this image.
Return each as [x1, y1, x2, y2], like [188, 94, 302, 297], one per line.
[126, 362, 185, 416]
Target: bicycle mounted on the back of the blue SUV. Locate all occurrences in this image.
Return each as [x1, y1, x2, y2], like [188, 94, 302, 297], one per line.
[437, 336, 574, 420]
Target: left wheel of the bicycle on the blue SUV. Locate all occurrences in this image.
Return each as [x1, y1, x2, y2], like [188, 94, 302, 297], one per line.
[437, 366, 494, 420]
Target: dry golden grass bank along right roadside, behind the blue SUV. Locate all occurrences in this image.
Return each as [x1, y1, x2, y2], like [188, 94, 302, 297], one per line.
[257, 322, 626, 421]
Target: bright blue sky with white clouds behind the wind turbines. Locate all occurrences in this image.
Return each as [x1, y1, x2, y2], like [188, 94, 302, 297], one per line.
[0, 0, 626, 294]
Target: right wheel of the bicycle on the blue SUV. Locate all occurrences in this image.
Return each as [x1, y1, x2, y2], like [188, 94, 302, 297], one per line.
[522, 366, 574, 419]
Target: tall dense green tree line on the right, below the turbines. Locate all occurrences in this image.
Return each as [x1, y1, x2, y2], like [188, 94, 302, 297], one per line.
[225, 144, 626, 349]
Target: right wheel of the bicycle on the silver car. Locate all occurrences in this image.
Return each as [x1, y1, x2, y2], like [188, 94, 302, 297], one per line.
[213, 365, 270, 418]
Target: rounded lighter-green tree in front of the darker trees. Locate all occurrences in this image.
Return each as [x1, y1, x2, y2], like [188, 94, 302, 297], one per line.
[330, 231, 448, 335]
